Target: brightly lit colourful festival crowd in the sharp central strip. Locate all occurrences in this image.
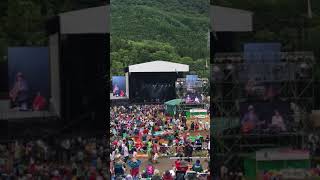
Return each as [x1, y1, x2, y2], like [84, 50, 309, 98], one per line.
[110, 105, 210, 179]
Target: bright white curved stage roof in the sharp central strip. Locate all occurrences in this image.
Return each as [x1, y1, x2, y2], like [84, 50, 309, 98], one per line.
[128, 61, 189, 72]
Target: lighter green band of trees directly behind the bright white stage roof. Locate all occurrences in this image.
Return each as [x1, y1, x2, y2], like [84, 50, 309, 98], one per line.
[111, 38, 209, 77]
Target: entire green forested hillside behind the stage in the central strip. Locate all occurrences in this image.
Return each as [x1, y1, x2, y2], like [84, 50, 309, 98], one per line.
[111, 0, 210, 76]
